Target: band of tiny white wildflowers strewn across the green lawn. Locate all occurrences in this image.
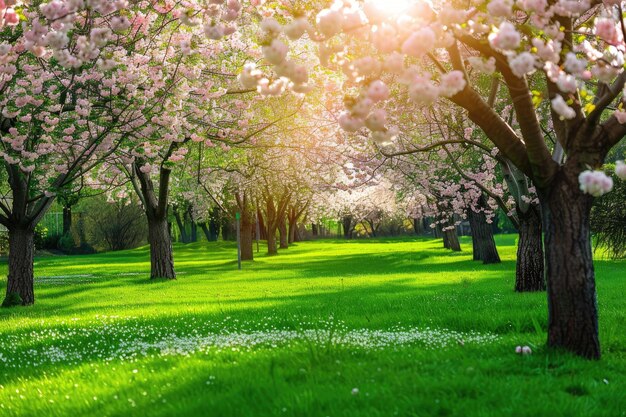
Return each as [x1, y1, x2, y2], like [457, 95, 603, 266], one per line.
[0, 315, 497, 368]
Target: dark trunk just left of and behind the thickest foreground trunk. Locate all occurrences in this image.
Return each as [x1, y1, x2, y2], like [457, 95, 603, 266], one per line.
[515, 205, 546, 292]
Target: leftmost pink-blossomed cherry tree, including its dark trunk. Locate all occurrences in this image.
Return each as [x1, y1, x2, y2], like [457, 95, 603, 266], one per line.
[0, 0, 130, 306]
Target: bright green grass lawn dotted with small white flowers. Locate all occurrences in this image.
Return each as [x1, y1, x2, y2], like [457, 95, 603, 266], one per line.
[0, 236, 626, 417]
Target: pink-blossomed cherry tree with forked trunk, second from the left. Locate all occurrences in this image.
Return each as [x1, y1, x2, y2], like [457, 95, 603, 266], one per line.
[92, 0, 302, 279]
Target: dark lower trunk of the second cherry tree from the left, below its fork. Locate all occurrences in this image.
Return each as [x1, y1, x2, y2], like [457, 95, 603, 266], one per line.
[148, 216, 176, 279]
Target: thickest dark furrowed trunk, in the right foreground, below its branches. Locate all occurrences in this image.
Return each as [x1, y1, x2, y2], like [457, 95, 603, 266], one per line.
[539, 171, 600, 359]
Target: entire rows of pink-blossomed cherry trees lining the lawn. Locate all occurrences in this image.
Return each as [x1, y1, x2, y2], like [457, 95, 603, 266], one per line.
[0, 0, 626, 358]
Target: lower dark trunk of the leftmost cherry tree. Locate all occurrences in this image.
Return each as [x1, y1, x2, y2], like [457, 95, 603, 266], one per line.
[2, 227, 35, 307]
